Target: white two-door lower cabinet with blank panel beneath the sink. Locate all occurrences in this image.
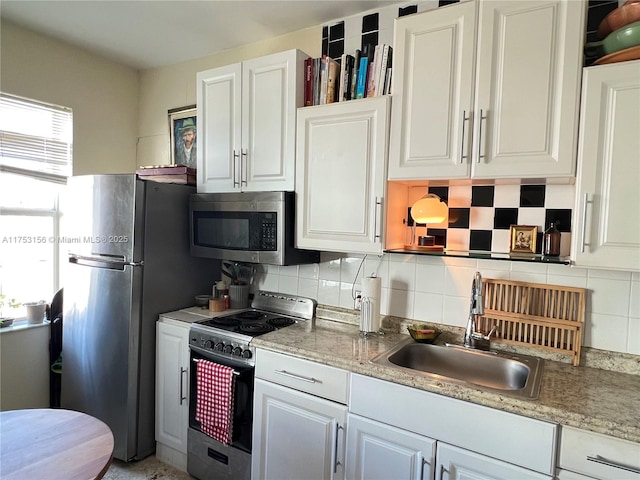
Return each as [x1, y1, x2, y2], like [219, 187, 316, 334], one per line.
[347, 374, 557, 480]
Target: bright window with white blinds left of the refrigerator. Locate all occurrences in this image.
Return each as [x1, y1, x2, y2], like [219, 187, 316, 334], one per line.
[0, 93, 73, 317]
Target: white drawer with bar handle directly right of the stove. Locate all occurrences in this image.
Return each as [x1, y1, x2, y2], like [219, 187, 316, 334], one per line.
[256, 349, 349, 405]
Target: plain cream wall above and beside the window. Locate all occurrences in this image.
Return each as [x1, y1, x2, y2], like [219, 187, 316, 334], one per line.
[0, 19, 139, 175]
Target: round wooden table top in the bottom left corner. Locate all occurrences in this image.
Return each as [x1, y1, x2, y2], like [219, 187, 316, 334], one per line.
[0, 408, 113, 480]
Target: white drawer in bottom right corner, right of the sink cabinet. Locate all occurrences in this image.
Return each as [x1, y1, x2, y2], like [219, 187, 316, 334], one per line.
[559, 427, 640, 480]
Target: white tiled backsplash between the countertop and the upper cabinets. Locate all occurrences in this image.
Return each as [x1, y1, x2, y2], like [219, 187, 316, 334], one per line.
[253, 253, 640, 355]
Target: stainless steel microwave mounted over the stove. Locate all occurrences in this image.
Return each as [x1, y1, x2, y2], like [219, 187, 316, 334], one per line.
[189, 192, 320, 265]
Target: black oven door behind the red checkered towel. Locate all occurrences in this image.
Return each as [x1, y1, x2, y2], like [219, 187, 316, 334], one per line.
[189, 348, 254, 453]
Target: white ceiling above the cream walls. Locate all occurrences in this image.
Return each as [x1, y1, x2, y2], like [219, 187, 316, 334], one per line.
[0, 0, 398, 69]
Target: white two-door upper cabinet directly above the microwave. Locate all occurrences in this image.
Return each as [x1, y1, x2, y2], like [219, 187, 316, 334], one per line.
[197, 50, 307, 193]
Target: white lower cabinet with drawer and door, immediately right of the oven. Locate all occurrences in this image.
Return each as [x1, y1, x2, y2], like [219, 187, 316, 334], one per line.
[251, 350, 348, 480]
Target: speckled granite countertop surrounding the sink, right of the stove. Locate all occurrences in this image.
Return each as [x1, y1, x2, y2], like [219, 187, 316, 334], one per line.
[252, 318, 640, 443]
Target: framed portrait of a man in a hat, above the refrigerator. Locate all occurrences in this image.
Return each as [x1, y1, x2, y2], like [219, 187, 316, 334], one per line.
[169, 105, 197, 168]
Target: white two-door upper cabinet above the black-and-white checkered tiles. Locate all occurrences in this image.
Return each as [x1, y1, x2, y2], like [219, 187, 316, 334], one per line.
[389, 0, 586, 180]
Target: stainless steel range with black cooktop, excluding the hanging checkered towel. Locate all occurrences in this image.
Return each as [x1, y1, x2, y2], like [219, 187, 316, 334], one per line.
[187, 291, 317, 480]
